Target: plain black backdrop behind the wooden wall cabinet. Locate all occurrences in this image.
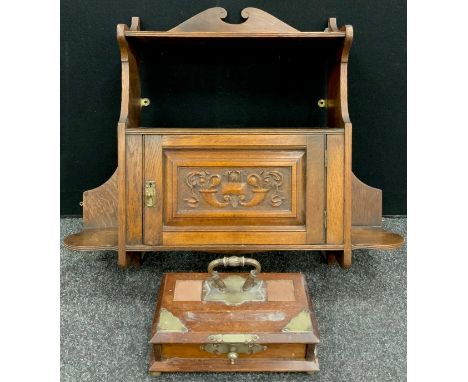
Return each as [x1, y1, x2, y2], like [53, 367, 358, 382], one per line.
[61, 0, 406, 215]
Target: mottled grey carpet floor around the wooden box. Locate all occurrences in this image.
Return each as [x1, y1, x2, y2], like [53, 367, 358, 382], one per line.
[61, 218, 406, 382]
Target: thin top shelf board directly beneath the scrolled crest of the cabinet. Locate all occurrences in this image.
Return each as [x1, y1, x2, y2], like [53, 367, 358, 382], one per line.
[125, 30, 346, 39]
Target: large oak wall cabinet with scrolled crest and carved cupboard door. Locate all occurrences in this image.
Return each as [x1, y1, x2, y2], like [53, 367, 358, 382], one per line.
[65, 8, 403, 267]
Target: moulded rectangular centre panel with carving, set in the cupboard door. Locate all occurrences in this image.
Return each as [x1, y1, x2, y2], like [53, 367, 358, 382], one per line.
[164, 150, 305, 226]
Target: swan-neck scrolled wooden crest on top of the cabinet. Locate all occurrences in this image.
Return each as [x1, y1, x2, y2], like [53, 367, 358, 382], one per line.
[169, 7, 299, 33]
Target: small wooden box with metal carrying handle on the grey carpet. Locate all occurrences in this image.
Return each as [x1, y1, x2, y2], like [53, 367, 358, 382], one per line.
[150, 256, 319, 375]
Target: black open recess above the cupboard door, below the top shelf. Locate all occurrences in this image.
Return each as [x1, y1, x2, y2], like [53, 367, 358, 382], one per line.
[135, 38, 332, 128]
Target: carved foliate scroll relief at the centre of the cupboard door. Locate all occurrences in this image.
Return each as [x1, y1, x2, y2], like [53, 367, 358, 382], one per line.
[181, 168, 290, 209]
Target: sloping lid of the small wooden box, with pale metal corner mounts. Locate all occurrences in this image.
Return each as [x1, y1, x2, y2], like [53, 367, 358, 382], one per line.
[150, 273, 319, 344]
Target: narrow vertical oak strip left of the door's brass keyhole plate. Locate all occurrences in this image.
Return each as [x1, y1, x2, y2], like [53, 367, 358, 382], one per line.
[126, 135, 143, 244]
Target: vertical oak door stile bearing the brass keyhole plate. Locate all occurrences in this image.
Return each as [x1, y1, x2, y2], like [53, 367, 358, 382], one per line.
[143, 135, 163, 245]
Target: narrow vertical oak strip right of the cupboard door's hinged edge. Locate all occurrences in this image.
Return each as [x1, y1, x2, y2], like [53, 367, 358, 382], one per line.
[327, 135, 344, 244]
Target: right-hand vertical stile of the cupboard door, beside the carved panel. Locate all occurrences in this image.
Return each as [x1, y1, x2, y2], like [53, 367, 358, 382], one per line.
[306, 135, 325, 244]
